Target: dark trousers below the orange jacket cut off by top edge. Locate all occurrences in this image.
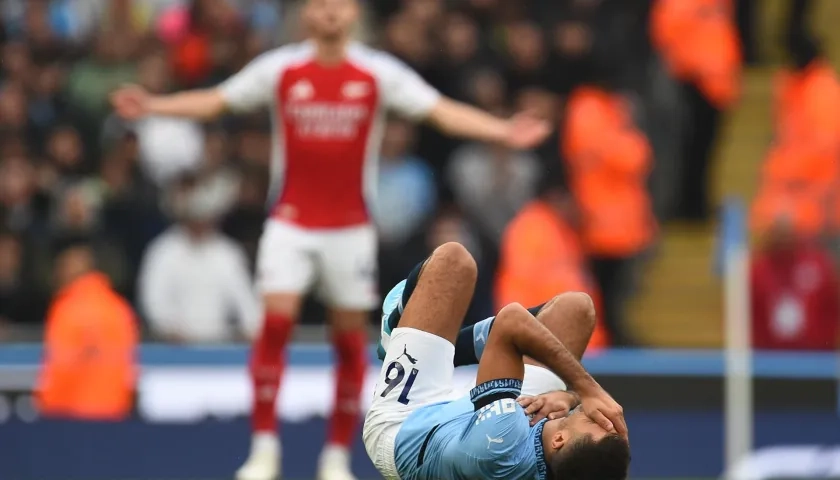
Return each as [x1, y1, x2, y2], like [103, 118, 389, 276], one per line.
[677, 84, 721, 221]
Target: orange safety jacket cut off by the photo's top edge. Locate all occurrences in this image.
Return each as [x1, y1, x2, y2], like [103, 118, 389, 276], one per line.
[650, 0, 742, 109]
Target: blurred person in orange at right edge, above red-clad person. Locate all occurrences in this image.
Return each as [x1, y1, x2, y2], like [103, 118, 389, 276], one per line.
[751, 36, 840, 238]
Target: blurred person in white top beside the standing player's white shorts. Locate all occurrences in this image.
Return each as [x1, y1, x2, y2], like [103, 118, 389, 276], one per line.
[138, 174, 260, 343]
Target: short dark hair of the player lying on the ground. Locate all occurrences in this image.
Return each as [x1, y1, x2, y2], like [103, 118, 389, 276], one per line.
[551, 435, 630, 480]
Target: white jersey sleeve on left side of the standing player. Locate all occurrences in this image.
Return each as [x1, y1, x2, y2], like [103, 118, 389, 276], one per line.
[219, 51, 286, 113]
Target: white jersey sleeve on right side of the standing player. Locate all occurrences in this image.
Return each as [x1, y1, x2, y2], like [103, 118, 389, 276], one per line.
[380, 53, 441, 120]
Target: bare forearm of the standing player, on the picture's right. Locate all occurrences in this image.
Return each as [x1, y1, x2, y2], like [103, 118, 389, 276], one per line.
[429, 98, 509, 143]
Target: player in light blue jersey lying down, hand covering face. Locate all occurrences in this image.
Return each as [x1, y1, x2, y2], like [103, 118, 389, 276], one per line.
[364, 243, 630, 480]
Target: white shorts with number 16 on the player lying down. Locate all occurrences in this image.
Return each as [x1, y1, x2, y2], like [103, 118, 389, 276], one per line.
[362, 328, 566, 480]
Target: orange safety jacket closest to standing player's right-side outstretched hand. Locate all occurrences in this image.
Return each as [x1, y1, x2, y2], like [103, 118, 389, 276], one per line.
[563, 87, 657, 257]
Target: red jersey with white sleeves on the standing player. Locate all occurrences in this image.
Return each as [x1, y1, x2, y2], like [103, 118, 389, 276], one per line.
[220, 42, 440, 228]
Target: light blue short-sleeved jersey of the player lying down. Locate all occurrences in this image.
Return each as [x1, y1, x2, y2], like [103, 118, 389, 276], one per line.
[394, 379, 546, 480]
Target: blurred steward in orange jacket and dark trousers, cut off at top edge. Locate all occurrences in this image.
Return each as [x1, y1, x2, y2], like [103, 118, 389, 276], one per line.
[650, 0, 741, 222]
